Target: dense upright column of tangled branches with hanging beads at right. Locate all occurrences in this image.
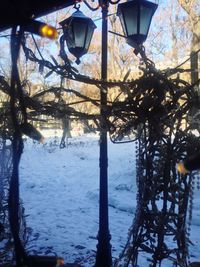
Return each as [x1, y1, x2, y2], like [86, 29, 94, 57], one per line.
[113, 58, 200, 267]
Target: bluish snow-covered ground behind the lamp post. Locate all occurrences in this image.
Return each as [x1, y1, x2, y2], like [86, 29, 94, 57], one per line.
[20, 133, 200, 267]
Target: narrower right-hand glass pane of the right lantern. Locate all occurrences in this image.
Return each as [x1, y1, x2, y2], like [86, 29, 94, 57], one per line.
[140, 6, 153, 35]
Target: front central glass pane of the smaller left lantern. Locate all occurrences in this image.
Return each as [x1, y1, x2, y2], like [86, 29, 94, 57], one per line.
[73, 21, 87, 48]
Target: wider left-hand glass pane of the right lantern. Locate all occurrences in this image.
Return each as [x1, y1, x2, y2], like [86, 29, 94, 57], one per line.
[123, 6, 138, 36]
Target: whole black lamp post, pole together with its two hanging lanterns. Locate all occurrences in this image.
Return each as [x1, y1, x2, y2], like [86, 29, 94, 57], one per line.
[60, 0, 157, 267]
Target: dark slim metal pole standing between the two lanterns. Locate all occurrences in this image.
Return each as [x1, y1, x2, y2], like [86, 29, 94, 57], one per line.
[95, 0, 112, 267]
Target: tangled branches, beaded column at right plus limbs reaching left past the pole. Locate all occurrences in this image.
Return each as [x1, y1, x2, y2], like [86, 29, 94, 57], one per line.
[0, 31, 200, 267]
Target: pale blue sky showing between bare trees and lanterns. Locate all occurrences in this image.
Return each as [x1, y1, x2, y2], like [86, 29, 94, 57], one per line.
[0, 0, 190, 82]
